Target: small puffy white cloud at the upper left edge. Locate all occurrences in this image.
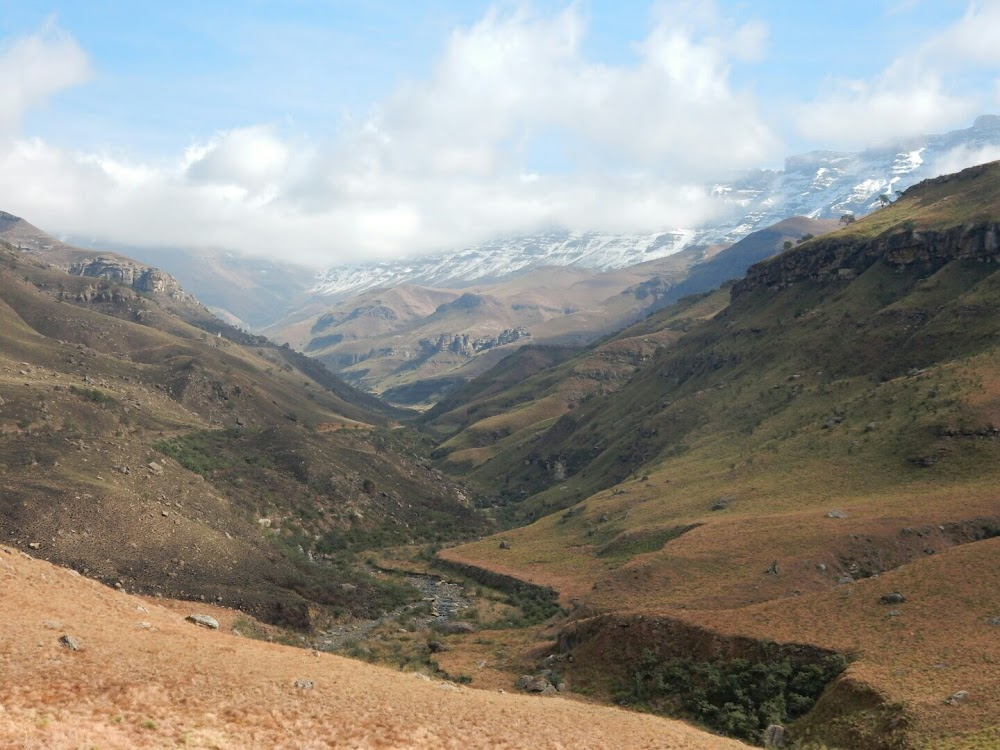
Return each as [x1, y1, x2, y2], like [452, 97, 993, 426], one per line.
[0, 19, 90, 136]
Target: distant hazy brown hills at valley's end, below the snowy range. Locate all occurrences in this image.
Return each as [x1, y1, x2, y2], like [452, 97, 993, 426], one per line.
[265, 246, 719, 405]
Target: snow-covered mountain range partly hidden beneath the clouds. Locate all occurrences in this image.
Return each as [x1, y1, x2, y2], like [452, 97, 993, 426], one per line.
[312, 115, 1000, 297]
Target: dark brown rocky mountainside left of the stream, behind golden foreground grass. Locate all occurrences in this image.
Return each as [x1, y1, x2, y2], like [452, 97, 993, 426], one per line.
[0, 215, 483, 628]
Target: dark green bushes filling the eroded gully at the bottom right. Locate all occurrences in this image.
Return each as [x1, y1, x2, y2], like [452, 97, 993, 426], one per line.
[620, 650, 847, 742]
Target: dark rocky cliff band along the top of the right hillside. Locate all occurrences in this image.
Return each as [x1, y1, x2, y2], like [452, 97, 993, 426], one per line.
[732, 222, 1000, 299]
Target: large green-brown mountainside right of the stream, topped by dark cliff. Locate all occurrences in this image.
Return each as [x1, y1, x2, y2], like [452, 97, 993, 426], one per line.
[425, 162, 1000, 749]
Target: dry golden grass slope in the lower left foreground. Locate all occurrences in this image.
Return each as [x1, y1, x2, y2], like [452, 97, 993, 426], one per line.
[0, 549, 743, 750]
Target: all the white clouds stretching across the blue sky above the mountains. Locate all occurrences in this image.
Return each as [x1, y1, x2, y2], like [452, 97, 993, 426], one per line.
[0, 2, 1000, 266]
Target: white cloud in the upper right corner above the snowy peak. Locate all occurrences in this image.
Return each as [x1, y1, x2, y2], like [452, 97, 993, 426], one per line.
[794, 0, 1000, 148]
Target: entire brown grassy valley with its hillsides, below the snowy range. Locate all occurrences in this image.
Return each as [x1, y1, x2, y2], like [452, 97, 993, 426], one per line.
[0, 163, 1000, 750]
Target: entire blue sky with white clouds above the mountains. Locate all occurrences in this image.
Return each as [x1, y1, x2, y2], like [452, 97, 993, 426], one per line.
[0, 0, 1000, 267]
